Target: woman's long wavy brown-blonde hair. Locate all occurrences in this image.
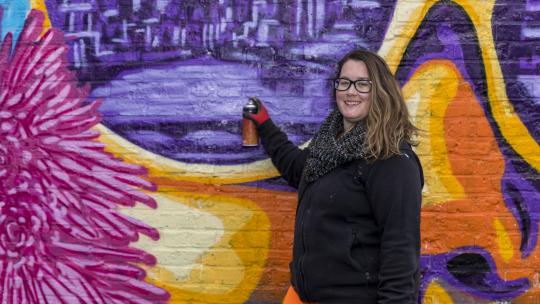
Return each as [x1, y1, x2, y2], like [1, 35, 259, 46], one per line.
[334, 50, 419, 161]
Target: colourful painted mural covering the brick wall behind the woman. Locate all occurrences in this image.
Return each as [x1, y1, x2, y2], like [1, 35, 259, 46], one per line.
[0, 0, 540, 303]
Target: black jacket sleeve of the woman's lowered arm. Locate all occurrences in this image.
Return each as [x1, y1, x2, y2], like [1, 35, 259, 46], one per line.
[366, 150, 423, 304]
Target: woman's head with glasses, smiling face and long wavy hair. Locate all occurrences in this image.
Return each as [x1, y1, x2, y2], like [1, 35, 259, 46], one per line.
[334, 51, 418, 160]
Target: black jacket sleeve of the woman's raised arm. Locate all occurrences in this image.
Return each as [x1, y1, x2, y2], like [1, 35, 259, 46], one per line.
[257, 119, 309, 188]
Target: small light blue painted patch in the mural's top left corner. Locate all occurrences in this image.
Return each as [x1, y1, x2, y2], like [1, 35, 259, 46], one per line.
[0, 0, 30, 45]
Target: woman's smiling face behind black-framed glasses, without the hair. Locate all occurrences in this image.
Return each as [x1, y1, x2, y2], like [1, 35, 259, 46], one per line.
[336, 59, 372, 125]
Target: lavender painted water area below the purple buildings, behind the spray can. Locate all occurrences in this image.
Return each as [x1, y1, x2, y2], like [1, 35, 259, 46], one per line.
[91, 57, 331, 164]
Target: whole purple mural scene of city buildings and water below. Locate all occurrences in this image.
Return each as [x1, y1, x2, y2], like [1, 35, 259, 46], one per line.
[42, 0, 395, 164]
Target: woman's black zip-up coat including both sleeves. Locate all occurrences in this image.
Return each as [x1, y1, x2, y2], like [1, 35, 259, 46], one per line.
[258, 120, 423, 304]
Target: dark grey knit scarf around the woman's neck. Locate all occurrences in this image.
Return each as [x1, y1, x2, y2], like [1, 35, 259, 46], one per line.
[304, 109, 366, 183]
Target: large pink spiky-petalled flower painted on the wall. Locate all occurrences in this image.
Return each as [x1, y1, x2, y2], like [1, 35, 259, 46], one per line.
[0, 11, 169, 304]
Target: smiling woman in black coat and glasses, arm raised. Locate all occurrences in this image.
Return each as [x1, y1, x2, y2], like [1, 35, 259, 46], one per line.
[246, 50, 423, 304]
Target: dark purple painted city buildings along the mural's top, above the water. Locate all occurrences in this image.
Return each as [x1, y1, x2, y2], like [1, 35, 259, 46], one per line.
[45, 0, 395, 81]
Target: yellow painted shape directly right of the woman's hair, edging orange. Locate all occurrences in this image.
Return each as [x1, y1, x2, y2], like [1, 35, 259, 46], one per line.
[403, 60, 465, 205]
